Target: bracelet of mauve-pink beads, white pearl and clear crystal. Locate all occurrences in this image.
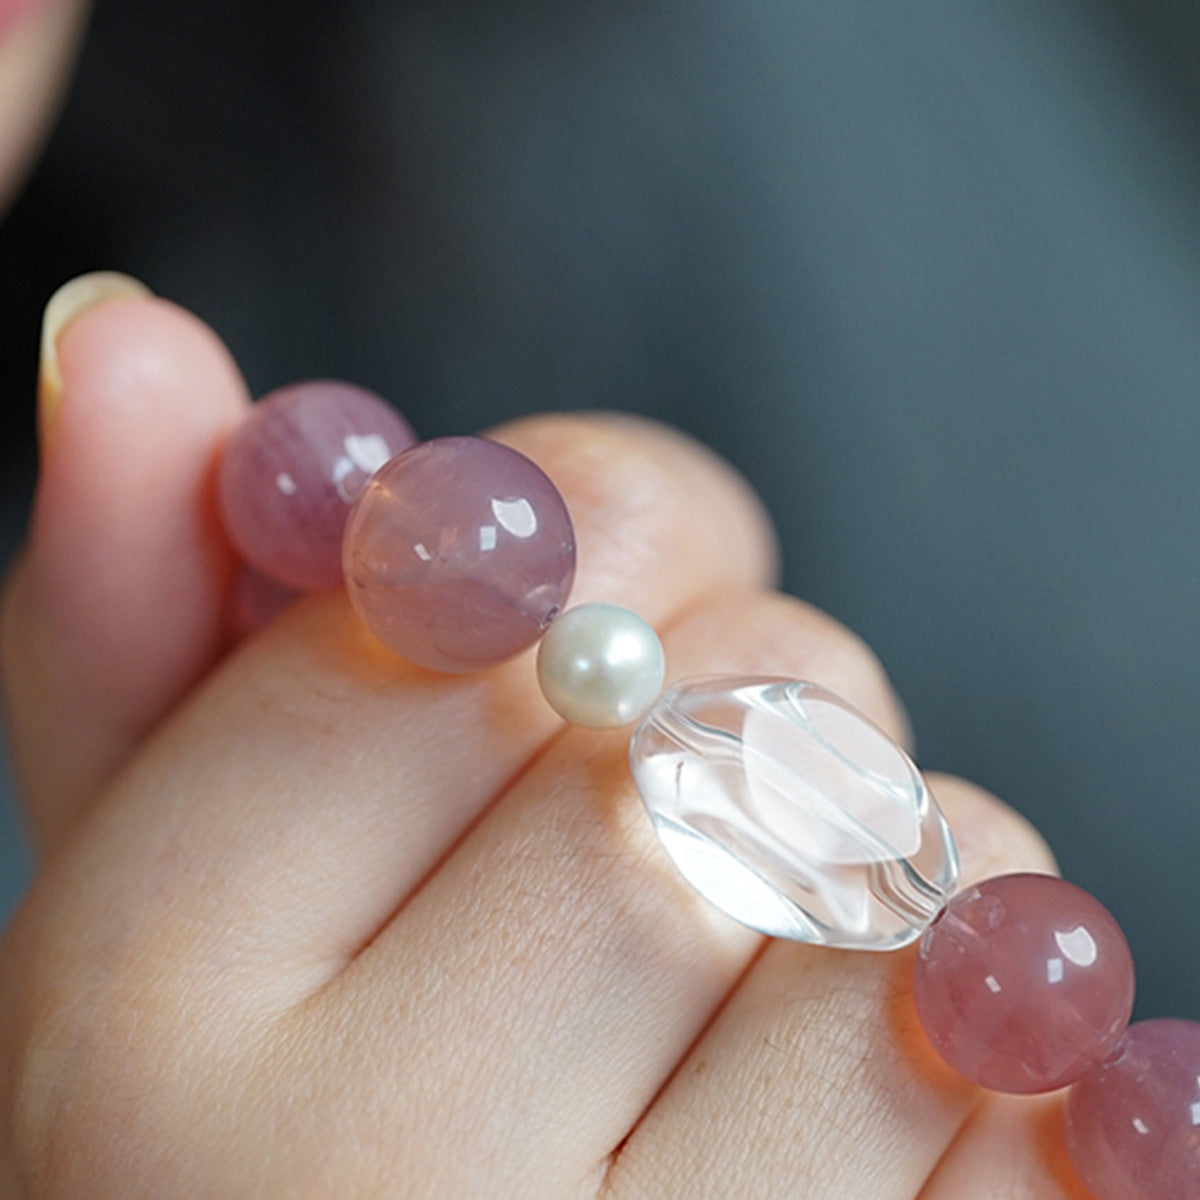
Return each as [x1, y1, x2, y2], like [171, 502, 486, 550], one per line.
[218, 382, 1200, 1200]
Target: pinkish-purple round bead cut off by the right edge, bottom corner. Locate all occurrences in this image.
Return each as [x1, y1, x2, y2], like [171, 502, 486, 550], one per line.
[1067, 1020, 1200, 1200]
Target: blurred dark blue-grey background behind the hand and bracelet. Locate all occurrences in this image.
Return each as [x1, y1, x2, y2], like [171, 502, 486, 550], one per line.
[0, 0, 1200, 1018]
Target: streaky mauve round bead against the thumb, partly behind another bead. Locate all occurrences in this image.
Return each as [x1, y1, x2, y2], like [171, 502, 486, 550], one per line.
[217, 380, 416, 592]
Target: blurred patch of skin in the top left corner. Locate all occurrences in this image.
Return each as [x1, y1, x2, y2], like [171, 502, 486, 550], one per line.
[0, 0, 86, 214]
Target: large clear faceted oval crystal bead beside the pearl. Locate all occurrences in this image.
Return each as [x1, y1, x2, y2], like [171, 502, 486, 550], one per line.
[630, 677, 958, 950]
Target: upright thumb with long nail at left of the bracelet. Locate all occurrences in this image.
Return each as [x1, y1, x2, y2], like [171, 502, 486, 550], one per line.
[0, 276, 247, 851]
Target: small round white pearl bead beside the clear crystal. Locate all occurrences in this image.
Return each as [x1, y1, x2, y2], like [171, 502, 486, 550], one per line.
[538, 604, 666, 730]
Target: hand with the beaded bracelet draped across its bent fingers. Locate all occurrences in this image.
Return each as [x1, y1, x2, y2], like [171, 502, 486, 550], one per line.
[0, 285, 1080, 1200]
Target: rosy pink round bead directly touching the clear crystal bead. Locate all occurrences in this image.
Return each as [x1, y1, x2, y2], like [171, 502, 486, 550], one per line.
[913, 875, 1134, 1093]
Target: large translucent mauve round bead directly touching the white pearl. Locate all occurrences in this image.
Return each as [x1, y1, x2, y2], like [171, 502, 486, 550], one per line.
[343, 438, 575, 671]
